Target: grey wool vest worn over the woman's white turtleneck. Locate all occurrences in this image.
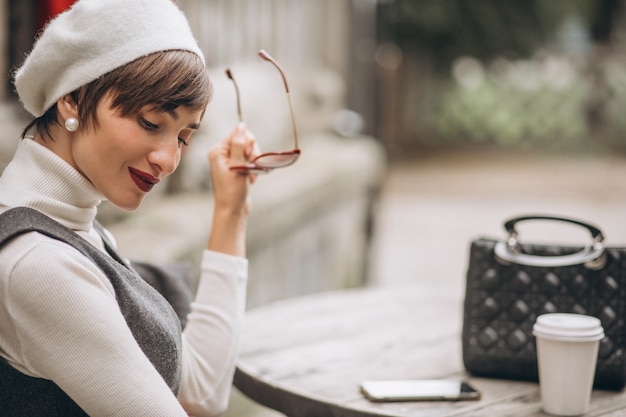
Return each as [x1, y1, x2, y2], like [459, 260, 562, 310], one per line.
[0, 207, 181, 417]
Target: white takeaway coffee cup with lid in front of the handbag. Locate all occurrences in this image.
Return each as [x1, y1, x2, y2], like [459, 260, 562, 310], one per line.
[533, 313, 604, 416]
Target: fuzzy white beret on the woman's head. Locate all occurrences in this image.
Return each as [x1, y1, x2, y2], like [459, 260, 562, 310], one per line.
[15, 0, 204, 117]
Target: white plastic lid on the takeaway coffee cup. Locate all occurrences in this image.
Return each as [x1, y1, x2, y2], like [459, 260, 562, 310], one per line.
[533, 313, 604, 342]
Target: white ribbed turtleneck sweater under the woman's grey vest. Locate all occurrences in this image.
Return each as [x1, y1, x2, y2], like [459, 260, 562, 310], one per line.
[0, 139, 248, 417]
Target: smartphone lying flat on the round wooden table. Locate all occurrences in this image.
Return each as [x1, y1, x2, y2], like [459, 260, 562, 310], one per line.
[361, 379, 480, 402]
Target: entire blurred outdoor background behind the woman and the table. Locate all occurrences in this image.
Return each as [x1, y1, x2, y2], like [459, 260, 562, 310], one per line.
[0, 0, 626, 416]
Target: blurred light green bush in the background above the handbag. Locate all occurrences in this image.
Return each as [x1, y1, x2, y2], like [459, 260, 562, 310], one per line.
[433, 72, 589, 149]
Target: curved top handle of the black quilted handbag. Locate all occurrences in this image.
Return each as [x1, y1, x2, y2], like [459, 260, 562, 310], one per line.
[494, 215, 606, 269]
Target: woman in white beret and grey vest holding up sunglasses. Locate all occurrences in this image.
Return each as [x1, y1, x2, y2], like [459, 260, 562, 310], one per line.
[0, 0, 258, 417]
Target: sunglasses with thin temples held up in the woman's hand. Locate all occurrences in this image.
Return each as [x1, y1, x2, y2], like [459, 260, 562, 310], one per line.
[226, 49, 300, 174]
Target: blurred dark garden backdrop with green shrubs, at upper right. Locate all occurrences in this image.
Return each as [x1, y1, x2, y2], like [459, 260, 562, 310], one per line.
[380, 0, 626, 151]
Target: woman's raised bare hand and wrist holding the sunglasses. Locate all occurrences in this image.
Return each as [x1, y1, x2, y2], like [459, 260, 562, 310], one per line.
[208, 123, 260, 256]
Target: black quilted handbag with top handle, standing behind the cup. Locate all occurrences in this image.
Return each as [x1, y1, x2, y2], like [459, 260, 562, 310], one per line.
[462, 216, 626, 390]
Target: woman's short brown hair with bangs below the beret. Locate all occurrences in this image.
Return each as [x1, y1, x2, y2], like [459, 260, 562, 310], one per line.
[22, 50, 213, 139]
